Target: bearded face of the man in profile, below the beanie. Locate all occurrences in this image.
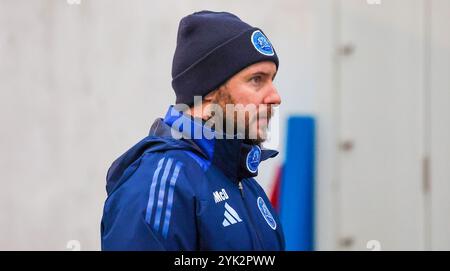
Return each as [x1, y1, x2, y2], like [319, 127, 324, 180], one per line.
[212, 61, 281, 144]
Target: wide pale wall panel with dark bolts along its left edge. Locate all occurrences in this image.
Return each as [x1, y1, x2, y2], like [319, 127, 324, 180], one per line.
[338, 0, 424, 250]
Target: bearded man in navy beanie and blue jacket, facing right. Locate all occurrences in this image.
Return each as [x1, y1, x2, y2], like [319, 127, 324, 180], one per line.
[101, 11, 284, 253]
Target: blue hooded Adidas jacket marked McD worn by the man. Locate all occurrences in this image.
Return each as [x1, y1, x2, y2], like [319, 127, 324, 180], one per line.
[101, 106, 285, 251]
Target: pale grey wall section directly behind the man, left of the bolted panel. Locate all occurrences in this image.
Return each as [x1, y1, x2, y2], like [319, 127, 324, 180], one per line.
[0, 0, 314, 250]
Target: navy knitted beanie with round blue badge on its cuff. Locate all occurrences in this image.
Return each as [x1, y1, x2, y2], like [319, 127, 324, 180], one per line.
[172, 11, 279, 106]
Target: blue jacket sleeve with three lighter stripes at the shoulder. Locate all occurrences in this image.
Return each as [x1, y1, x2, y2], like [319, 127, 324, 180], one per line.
[101, 153, 199, 250]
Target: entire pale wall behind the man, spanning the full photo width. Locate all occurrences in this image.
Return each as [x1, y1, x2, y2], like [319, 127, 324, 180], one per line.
[0, 0, 450, 250]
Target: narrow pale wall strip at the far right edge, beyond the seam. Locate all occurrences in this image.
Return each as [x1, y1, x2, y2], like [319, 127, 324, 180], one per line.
[430, 0, 450, 250]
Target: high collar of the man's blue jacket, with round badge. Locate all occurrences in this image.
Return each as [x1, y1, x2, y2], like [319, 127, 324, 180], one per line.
[158, 106, 278, 181]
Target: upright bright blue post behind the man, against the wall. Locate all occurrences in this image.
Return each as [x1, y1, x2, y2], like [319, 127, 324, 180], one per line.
[280, 116, 315, 250]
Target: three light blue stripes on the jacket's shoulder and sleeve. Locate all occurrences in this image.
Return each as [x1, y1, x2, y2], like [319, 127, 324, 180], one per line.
[145, 157, 183, 238]
